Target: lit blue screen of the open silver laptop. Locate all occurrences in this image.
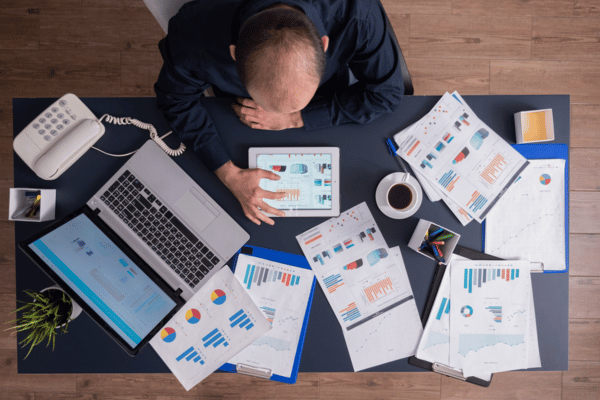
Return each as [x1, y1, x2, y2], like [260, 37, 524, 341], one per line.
[29, 214, 177, 348]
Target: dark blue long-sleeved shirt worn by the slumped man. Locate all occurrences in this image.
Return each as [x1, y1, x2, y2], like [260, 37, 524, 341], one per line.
[154, 0, 404, 171]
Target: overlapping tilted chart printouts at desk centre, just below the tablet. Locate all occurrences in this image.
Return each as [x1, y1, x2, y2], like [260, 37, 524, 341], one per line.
[296, 202, 423, 371]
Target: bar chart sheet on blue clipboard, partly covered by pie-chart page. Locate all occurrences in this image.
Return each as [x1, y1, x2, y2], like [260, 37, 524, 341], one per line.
[229, 254, 314, 378]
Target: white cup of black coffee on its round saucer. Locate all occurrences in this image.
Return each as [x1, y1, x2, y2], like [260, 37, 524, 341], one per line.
[375, 172, 423, 219]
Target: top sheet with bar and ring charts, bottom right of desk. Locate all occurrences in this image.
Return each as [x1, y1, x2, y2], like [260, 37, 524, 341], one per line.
[444, 260, 538, 376]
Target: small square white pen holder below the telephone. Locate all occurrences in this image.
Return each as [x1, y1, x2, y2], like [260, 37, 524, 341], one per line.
[8, 188, 56, 222]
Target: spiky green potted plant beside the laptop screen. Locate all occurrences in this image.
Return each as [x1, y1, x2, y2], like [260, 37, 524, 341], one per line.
[7, 286, 81, 358]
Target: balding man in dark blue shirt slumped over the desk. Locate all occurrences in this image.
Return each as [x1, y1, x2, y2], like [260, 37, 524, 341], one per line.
[154, 0, 404, 225]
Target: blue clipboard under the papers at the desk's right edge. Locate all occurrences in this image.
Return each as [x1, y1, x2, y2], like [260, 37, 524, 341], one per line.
[481, 143, 569, 274]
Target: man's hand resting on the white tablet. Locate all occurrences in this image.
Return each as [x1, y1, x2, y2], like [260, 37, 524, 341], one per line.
[215, 161, 286, 225]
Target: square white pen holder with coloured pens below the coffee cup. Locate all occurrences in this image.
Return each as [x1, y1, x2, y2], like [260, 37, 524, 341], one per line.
[408, 219, 460, 264]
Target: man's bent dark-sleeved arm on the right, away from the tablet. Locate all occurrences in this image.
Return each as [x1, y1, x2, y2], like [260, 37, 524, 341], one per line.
[302, 0, 404, 130]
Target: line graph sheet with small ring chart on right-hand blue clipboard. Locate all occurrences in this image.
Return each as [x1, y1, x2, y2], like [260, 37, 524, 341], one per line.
[485, 160, 567, 271]
